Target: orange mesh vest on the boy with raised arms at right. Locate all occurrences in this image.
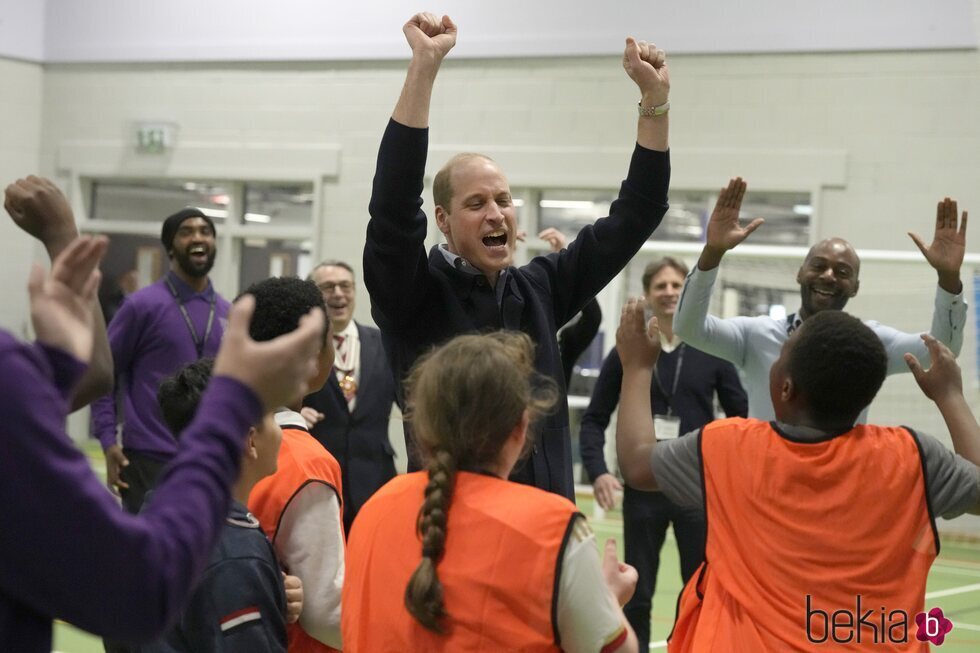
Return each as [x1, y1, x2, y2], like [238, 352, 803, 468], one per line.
[668, 419, 939, 653]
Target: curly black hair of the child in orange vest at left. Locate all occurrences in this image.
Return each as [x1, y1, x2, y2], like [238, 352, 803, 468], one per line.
[240, 277, 327, 343]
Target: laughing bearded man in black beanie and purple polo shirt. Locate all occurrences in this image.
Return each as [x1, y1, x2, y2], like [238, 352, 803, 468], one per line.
[92, 208, 229, 513]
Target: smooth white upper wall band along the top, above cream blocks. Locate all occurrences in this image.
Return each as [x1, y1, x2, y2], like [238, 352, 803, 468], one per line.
[38, 0, 977, 62]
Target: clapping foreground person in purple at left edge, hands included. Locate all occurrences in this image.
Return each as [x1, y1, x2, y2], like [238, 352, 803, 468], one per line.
[0, 256, 324, 640]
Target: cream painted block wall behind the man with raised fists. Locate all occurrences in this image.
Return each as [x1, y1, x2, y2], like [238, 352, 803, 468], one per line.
[41, 51, 980, 258]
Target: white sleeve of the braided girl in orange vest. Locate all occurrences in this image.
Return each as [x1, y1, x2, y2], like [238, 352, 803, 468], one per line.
[558, 517, 626, 653]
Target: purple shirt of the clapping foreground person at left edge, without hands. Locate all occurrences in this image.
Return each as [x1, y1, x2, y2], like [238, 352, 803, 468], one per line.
[0, 330, 262, 653]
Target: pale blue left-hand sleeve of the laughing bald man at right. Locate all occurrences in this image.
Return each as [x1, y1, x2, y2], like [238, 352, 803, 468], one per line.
[674, 265, 747, 368]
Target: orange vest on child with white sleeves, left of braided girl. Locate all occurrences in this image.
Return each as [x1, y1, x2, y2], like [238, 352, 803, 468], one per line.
[248, 427, 344, 653]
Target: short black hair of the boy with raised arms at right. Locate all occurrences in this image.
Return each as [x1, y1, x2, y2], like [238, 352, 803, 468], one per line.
[786, 310, 888, 424]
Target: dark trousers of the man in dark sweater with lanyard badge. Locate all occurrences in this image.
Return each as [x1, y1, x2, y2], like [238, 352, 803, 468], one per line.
[623, 486, 705, 651]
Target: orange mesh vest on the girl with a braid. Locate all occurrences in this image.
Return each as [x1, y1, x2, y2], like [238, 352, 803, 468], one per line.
[341, 472, 580, 653]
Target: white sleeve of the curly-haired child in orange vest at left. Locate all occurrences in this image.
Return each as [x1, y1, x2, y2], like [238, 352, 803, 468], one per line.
[275, 483, 344, 649]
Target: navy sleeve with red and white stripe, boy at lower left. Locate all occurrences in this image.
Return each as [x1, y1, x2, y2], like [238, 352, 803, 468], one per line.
[174, 558, 286, 653]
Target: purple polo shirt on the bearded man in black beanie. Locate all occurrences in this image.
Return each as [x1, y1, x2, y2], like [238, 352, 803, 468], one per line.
[92, 272, 231, 460]
